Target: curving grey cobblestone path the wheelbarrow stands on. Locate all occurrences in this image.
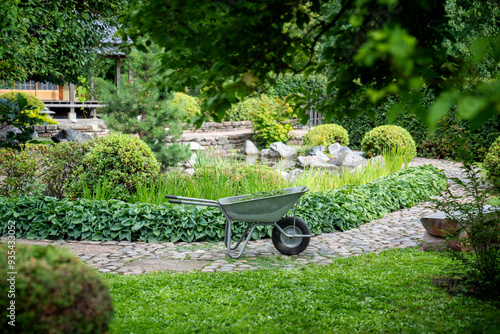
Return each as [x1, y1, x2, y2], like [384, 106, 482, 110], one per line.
[13, 158, 463, 274]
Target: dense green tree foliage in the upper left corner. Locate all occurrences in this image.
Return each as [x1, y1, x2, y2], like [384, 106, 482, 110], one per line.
[0, 0, 128, 85]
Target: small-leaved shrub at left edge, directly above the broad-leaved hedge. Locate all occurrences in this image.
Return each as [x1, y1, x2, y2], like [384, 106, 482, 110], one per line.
[0, 144, 49, 197]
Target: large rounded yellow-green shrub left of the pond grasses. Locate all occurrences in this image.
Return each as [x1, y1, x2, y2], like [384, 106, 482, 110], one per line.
[72, 133, 160, 200]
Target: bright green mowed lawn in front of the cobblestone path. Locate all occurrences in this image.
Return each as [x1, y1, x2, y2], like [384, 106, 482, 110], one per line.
[104, 249, 500, 333]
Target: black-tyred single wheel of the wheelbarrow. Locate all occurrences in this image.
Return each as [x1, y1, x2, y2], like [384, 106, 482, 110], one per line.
[272, 217, 311, 255]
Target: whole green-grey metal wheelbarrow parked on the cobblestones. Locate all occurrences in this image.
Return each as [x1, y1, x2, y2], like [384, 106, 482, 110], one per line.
[165, 187, 314, 259]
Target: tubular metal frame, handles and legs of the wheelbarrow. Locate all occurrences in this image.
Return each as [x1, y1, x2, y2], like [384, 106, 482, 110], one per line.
[165, 187, 314, 259]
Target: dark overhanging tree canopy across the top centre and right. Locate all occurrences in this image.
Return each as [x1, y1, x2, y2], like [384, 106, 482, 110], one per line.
[128, 0, 500, 127]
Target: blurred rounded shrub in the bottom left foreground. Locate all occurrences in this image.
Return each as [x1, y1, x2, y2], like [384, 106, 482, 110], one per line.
[0, 241, 113, 334]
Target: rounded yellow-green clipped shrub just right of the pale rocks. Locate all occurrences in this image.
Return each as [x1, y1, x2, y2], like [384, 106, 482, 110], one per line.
[361, 125, 417, 160]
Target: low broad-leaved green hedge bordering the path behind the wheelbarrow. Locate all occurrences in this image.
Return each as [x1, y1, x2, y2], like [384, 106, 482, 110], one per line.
[0, 166, 446, 242]
